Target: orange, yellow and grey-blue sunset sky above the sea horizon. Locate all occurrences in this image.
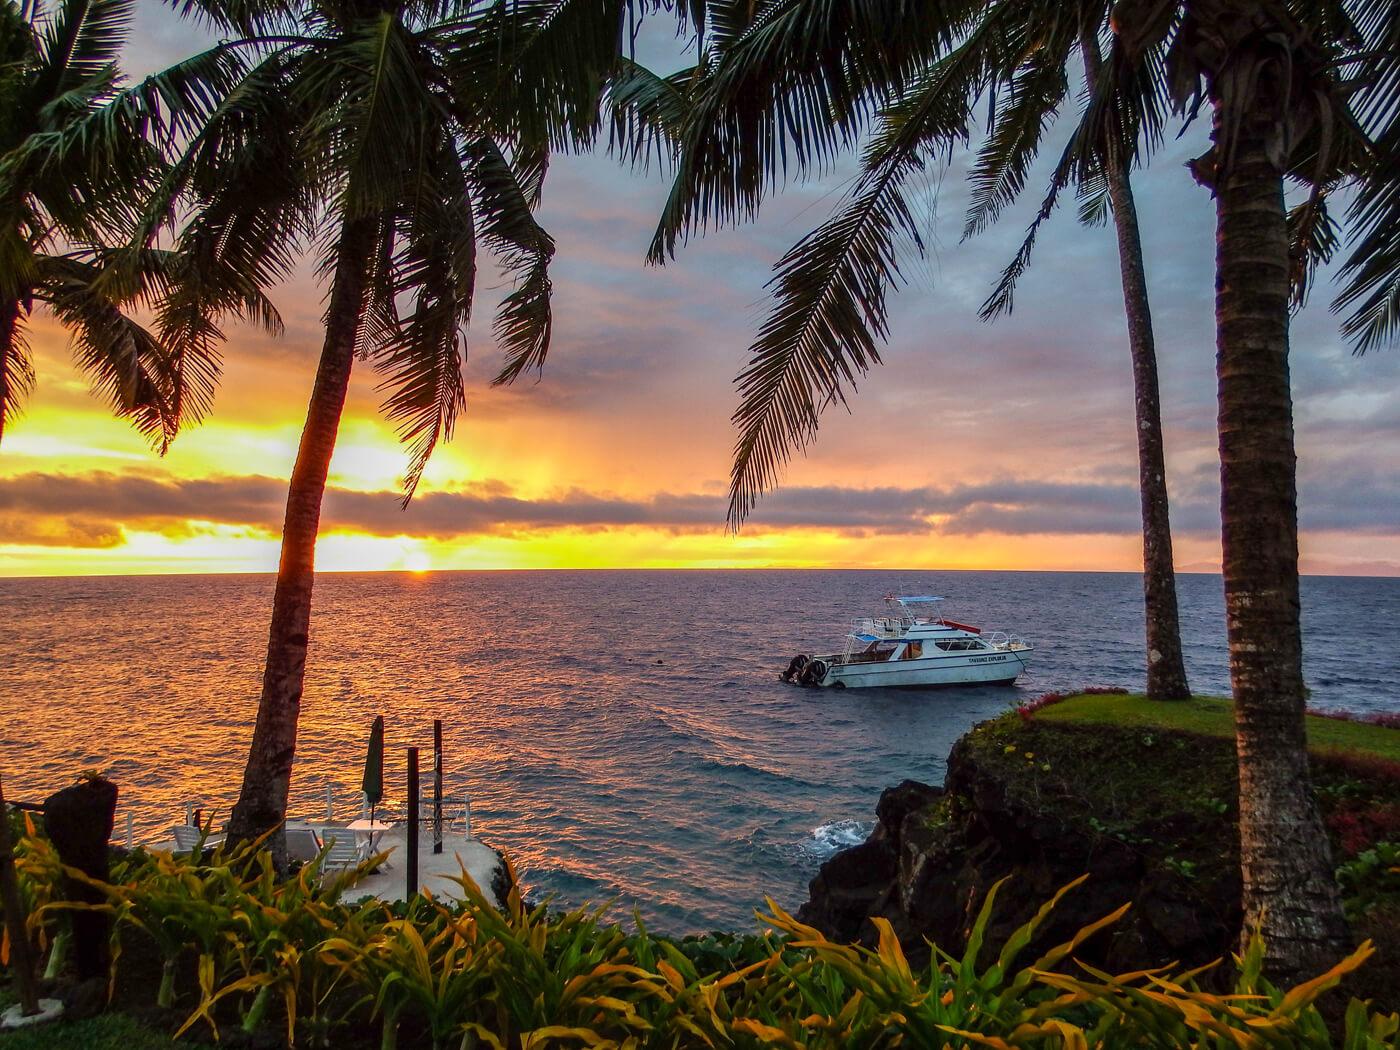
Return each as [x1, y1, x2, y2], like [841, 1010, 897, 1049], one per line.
[0, 0, 1400, 575]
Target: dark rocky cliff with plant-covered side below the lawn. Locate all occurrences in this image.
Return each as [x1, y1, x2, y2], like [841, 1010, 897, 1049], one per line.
[798, 700, 1400, 1000]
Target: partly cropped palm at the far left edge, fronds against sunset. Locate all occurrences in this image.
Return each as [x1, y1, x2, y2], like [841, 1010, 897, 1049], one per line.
[0, 0, 280, 452]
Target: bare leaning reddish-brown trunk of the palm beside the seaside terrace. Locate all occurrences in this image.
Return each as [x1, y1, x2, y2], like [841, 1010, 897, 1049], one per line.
[228, 218, 374, 865]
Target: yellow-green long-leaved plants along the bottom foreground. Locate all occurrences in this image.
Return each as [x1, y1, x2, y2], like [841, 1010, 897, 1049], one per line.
[2, 834, 1400, 1050]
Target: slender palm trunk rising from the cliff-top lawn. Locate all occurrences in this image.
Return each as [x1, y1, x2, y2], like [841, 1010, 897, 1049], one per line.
[1079, 32, 1191, 700]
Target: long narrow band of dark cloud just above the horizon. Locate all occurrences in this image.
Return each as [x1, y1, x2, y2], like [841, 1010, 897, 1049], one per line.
[0, 470, 1400, 547]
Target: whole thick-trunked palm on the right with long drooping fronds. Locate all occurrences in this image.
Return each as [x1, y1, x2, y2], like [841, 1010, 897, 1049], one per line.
[617, 0, 1400, 976]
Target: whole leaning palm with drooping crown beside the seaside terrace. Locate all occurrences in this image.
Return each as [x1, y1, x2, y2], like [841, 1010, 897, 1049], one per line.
[158, 0, 635, 857]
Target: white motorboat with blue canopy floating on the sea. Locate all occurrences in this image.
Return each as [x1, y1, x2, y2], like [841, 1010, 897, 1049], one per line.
[781, 595, 1033, 689]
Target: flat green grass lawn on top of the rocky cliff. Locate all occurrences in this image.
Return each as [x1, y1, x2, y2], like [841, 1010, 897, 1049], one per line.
[1035, 693, 1400, 762]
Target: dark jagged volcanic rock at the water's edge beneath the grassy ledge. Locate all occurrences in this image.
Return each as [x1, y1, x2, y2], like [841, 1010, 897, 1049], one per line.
[798, 739, 1240, 969]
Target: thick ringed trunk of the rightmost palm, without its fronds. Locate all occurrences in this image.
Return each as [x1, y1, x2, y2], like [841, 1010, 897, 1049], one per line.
[1212, 91, 1348, 980]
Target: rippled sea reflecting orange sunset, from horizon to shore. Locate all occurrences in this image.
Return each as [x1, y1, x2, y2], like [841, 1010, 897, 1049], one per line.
[0, 571, 1400, 932]
